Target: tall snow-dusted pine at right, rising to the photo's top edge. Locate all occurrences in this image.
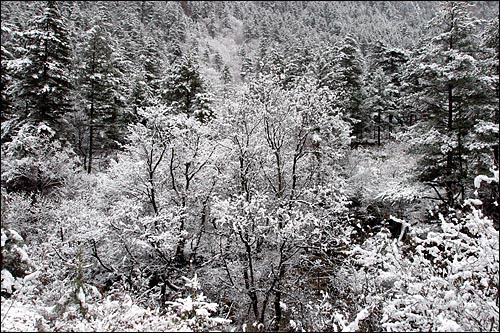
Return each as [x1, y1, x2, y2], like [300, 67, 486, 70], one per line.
[410, 1, 485, 206]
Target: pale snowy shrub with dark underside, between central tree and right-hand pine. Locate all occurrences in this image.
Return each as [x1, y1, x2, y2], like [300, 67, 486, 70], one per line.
[346, 141, 427, 242]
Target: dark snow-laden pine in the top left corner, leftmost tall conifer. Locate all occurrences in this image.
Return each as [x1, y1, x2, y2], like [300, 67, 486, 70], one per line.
[10, 1, 73, 137]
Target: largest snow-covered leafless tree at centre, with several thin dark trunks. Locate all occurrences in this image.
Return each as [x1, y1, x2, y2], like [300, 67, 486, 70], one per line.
[207, 75, 350, 330]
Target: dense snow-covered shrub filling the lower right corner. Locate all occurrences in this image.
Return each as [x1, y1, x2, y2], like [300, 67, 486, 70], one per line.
[352, 171, 499, 332]
